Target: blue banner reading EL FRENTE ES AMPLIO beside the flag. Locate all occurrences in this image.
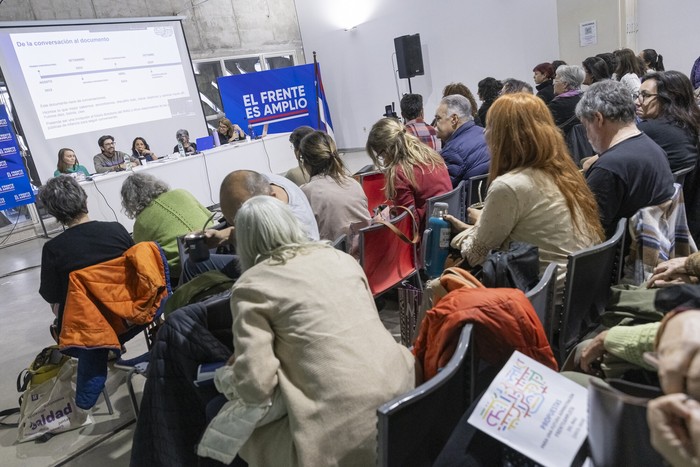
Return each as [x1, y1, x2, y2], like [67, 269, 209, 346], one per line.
[218, 64, 333, 135]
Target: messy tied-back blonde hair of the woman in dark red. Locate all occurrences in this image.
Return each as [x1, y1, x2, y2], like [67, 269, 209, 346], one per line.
[366, 118, 445, 199]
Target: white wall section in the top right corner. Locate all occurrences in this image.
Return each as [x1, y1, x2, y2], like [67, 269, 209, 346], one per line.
[637, 0, 700, 75]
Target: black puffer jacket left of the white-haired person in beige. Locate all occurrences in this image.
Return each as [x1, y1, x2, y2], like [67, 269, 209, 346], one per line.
[131, 293, 233, 467]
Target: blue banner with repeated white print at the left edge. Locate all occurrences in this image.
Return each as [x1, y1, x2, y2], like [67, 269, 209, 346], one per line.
[0, 104, 34, 210]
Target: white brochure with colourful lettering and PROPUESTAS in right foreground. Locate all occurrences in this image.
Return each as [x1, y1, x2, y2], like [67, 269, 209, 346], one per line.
[469, 352, 588, 466]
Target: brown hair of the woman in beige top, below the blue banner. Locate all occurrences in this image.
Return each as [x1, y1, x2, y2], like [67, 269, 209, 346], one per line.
[299, 131, 348, 185]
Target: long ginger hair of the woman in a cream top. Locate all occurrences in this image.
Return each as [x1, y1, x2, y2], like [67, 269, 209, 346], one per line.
[486, 93, 605, 241]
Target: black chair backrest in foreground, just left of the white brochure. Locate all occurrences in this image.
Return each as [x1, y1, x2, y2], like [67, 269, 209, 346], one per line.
[377, 324, 474, 467]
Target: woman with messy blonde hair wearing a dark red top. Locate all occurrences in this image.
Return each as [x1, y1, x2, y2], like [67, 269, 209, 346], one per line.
[366, 117, 452, 232]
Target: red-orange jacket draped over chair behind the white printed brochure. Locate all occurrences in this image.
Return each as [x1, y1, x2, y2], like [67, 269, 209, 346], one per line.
[413, 280, 557, 380]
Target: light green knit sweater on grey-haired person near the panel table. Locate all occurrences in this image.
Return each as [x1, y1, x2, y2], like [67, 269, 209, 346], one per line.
[134, 190, 211, 279]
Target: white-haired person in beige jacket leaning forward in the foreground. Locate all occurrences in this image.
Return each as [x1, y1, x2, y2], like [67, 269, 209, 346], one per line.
[198, 196, 420, 465]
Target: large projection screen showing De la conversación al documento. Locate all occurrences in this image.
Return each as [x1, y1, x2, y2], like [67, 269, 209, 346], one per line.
[0, 17, 208, 181]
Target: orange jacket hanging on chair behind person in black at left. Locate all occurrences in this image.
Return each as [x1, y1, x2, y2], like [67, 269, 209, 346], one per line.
[59, 242, 168, 350]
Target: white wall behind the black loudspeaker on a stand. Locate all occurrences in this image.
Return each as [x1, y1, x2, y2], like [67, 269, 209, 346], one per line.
[296, 0, 559, 148]
